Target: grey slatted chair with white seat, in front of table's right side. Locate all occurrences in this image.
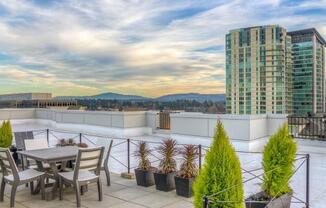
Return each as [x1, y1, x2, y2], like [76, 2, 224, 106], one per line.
[59, 147, 104, 207]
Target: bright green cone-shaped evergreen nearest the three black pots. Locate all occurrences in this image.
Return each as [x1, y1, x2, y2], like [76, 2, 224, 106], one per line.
[193, 122, 244, 208]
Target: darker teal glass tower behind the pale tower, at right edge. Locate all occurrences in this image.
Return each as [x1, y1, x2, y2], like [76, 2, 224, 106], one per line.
[288, 28, 326, 114]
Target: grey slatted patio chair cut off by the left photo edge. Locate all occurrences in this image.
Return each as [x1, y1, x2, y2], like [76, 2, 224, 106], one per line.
[0, 148, 45, 207]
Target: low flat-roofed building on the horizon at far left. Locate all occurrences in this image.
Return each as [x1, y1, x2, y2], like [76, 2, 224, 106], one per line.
[0, 93, 79, 109]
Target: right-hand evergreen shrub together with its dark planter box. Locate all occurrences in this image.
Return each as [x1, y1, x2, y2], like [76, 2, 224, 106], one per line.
[246, 124, 297, 208]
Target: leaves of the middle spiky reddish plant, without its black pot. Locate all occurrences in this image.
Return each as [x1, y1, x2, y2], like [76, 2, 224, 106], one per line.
[158, 139, 177, 174]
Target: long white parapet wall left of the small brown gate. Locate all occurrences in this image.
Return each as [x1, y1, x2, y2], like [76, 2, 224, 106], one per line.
[0, 109, 155, 137]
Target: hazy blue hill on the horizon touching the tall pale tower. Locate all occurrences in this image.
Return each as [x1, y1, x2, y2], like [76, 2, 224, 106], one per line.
[156, 93, 225, 102]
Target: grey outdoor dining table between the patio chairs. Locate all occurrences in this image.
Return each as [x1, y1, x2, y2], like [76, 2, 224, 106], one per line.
[17, 146, 78, 199]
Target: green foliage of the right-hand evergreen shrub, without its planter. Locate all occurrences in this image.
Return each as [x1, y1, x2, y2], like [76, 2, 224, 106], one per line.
[262, 124, 297, 197]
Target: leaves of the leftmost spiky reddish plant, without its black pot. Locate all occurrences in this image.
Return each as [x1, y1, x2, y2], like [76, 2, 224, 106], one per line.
[135, 141, 151, 171]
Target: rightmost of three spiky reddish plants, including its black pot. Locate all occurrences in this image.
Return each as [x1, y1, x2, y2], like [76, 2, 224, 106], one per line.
[174, 145, 198, 198]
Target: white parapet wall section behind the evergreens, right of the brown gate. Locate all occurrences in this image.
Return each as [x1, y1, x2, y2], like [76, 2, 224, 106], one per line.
[170, 113, 287, 151]
